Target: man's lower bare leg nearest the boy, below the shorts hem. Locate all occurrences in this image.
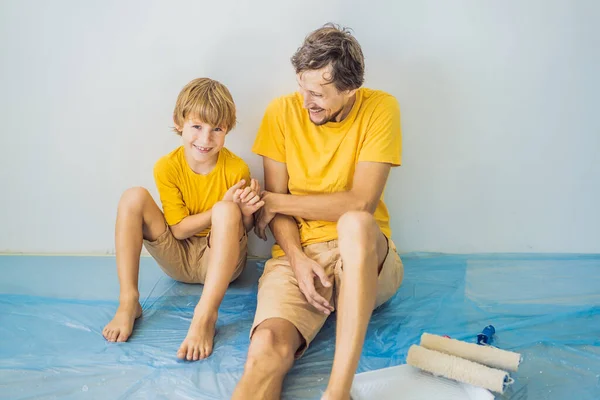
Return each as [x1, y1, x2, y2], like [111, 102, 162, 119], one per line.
[231, 318, 303, 400]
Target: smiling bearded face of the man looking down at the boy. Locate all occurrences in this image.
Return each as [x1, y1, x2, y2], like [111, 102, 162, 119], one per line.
[296, 66, 356, 125]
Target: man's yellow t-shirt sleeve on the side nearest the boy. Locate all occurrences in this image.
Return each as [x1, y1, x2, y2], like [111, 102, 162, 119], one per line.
[252, 100, 285, 163]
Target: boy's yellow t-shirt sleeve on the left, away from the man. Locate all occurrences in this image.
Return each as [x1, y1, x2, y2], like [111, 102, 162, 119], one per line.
[154, 159, 190, 225]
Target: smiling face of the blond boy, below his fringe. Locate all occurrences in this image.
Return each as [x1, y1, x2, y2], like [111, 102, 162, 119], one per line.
[176, 119, 227, 163]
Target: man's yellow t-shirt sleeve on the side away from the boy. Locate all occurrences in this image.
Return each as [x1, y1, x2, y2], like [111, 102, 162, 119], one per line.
[358, 96, 402, 166]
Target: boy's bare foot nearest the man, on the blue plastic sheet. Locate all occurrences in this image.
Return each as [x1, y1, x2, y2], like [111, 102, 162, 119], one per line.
[177, 312, 218, 361]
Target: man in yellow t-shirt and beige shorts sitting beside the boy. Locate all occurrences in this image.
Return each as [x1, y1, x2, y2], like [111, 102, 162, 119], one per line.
[233, 24, 404, 400]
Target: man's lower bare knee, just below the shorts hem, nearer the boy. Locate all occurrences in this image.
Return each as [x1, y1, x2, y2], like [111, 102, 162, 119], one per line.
[247, 326, 296, 372]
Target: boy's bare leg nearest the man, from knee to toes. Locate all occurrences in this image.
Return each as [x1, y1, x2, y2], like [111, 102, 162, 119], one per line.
[177, 201, 244, 361]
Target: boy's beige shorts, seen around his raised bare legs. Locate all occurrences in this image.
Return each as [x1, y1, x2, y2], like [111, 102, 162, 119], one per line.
[144, 226, 248, 283]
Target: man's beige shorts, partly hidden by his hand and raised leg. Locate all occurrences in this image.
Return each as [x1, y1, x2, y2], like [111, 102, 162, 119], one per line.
[250, 239, 404, 357]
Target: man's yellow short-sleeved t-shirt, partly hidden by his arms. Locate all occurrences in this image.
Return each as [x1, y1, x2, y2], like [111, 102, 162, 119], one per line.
[252, 88, 402, 257]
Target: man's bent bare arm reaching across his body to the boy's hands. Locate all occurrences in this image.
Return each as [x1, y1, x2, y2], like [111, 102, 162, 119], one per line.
[263, 162, 391, 222]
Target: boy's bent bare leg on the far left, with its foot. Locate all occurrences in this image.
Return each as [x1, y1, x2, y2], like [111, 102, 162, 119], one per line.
[102, 188, 166, 342]
